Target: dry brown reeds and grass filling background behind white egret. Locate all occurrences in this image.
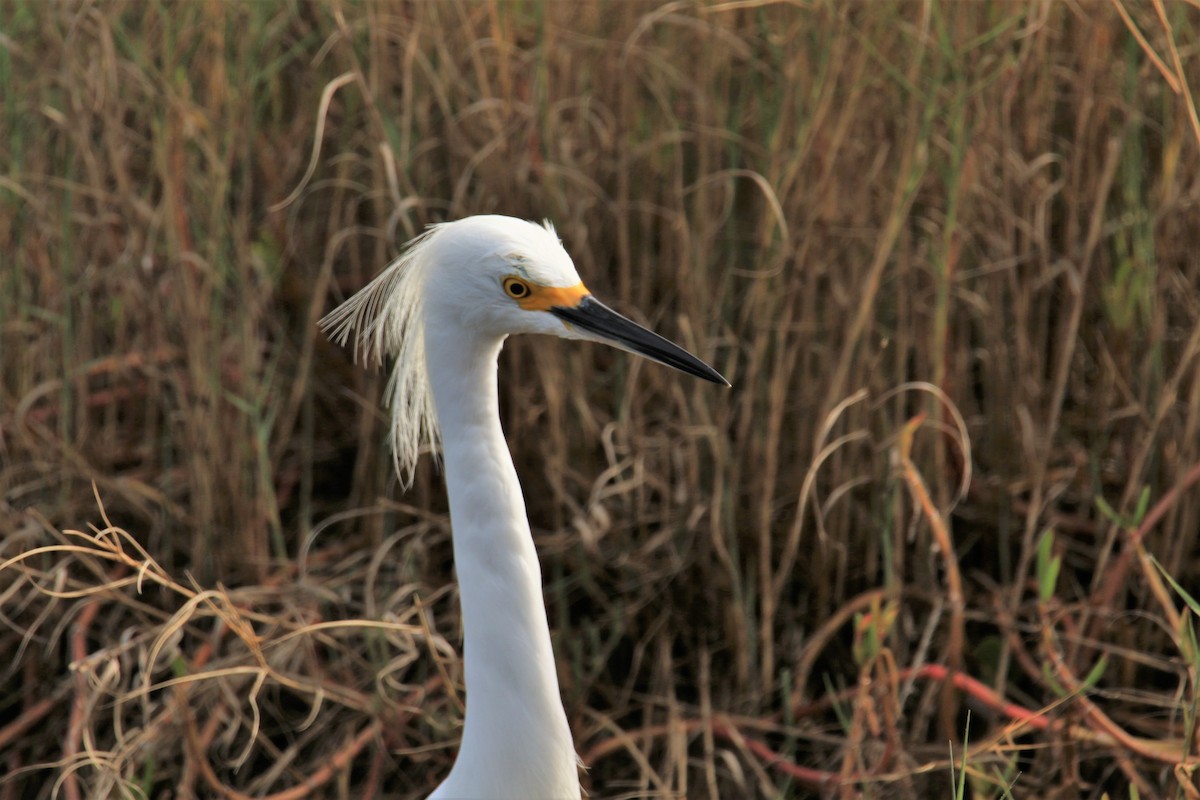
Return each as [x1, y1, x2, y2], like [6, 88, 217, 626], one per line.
[0, 0, 1200, 799]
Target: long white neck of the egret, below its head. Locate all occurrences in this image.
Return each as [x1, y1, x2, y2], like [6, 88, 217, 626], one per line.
[425, 326, 580, 800]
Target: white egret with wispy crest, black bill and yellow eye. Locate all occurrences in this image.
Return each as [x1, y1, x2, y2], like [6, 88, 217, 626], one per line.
[320, 216, 728, 800]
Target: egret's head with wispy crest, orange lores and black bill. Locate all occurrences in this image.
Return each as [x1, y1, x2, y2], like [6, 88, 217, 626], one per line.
[320, 215, 728, 475]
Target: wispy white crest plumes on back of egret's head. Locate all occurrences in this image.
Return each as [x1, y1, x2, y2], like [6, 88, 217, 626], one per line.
[319, 225, 440, 488]
